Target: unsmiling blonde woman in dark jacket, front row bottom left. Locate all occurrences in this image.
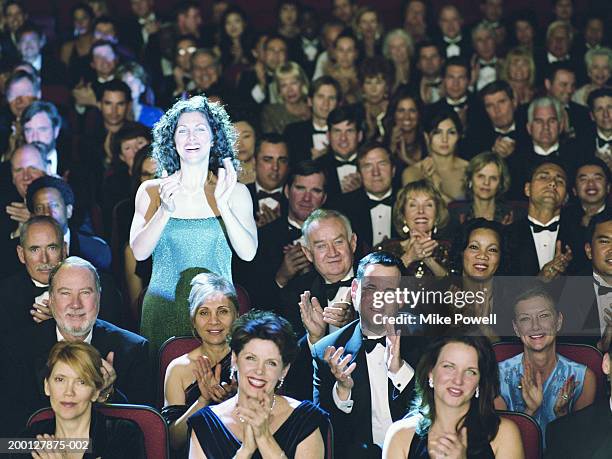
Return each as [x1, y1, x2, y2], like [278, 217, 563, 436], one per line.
[9, 341, 147, 459]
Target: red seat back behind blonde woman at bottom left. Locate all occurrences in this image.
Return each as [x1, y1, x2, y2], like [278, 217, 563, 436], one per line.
[28, 404, 170, 459]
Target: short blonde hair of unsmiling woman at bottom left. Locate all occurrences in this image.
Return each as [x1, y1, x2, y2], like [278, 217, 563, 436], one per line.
[45, 341, 104, 390]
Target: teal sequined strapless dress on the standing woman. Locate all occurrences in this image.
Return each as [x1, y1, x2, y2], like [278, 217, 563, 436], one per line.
[140, 217, 232, 356]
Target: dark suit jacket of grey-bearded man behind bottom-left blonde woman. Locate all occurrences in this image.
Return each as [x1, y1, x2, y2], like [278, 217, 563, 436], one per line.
[0, 319, 152, 433]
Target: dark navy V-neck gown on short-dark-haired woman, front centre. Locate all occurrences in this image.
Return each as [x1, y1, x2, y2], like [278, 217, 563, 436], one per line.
[188, 400, 328, 459]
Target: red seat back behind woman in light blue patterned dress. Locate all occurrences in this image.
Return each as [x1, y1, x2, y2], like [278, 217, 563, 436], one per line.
[493, 343, 605, 398]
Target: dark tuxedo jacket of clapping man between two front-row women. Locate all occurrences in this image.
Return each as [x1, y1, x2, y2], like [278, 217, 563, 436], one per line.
[313, 320, 420, 458]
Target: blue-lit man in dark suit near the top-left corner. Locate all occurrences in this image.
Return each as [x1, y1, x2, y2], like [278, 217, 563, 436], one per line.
[17, 23, 67, 85]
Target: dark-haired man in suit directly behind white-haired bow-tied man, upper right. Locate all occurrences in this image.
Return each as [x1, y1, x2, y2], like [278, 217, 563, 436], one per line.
[544, 62, 593, 139]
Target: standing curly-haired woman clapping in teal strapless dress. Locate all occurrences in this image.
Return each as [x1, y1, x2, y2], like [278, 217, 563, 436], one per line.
[130, 96, 257, 350]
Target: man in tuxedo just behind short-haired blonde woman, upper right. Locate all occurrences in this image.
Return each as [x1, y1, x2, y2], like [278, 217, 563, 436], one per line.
[471, 22, 501, 91]
